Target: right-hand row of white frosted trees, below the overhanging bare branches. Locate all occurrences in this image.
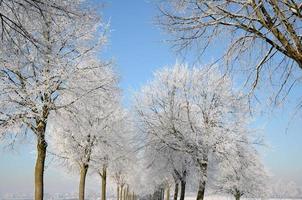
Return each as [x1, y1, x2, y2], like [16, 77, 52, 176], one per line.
[135, 64, 267, 200]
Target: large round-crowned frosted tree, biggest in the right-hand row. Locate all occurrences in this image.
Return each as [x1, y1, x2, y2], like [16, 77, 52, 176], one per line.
[135, 64, 248, 200]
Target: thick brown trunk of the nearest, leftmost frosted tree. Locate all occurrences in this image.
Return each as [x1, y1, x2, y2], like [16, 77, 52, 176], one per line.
[35, 122, 47, 200]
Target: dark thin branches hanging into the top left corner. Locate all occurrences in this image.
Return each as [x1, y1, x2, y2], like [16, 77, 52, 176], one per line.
[0, 0, 91, 47]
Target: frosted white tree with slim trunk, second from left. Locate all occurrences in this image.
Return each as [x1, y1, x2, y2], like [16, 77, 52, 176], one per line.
[49, 69, 118, 200]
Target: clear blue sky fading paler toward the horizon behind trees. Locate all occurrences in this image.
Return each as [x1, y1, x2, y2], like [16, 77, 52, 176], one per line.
[0, 0, 302, 197]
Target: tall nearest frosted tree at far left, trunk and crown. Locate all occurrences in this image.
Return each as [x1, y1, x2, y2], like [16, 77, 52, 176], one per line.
[0, 3, 110, 200]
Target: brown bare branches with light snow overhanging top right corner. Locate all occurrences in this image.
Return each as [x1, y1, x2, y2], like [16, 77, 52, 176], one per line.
[160, 0, 302, 104]
